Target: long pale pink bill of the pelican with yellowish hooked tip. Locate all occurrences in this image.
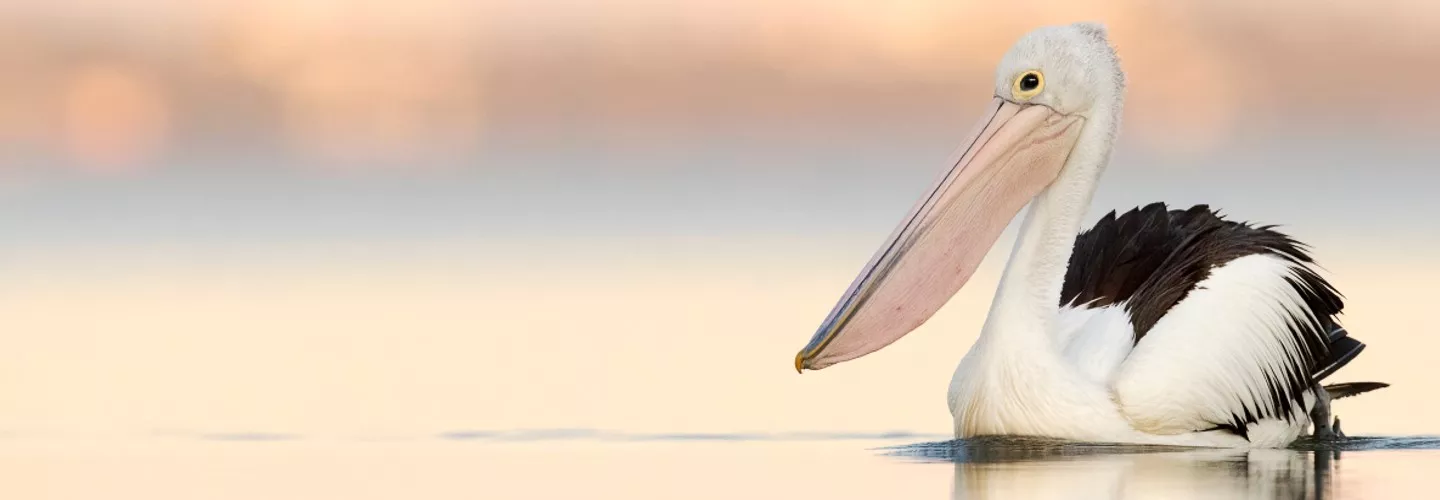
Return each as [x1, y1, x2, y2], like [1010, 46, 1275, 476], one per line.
[795, 98, 1084, 370]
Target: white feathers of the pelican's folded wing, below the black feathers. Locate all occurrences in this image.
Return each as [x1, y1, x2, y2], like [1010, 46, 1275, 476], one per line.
[1113, 254, 1310, 442]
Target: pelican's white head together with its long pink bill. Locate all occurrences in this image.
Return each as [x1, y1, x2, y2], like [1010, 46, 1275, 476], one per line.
[795, 23, 1125, 370]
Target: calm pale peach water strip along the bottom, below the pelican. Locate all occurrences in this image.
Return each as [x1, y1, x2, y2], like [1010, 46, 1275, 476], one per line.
[0, 432, 1440, 500]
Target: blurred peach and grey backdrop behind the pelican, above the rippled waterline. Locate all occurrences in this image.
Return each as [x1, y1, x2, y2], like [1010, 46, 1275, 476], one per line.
[0, 0, 1440, 439]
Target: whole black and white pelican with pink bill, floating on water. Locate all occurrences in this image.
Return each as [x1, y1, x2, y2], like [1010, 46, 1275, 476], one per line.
[795, 23, 1387, 448]
